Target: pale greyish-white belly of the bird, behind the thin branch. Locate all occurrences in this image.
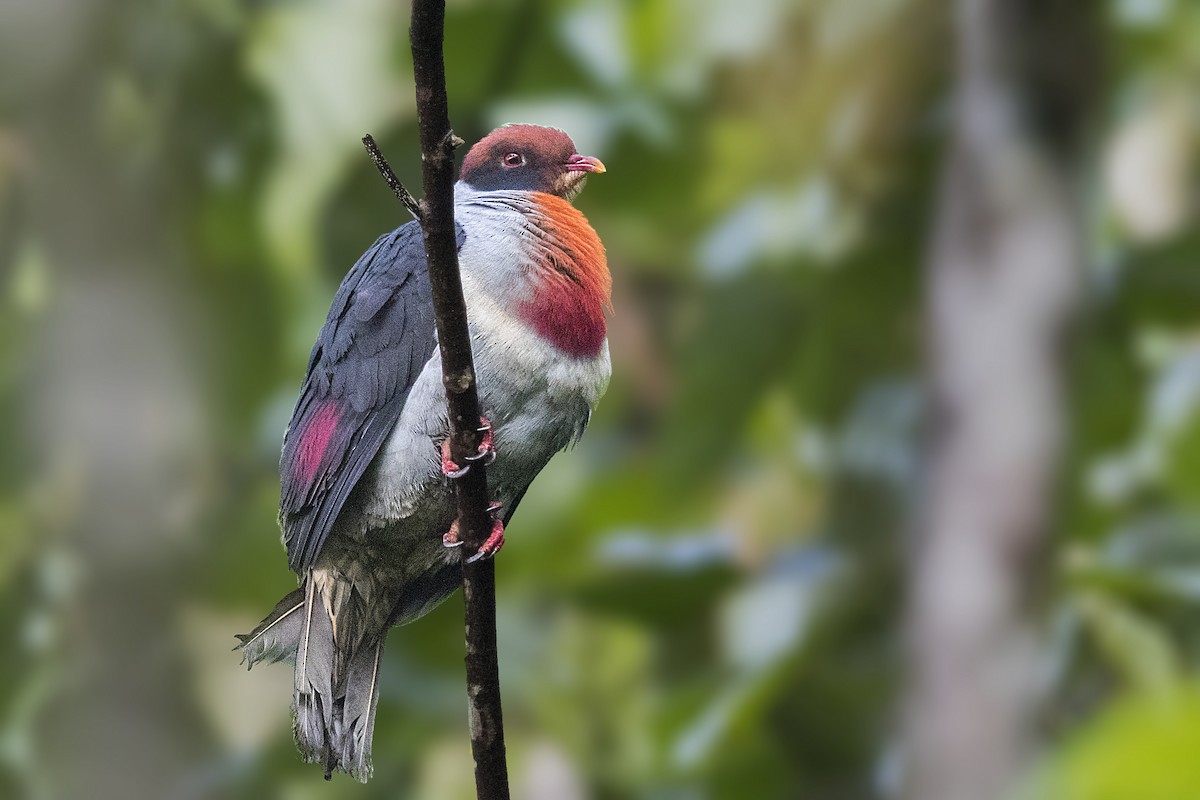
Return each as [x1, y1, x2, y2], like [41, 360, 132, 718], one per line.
[318, 335, 608, 625]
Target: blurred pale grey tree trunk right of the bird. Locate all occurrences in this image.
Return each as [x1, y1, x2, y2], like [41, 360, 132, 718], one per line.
[904, 0, 1098, 800]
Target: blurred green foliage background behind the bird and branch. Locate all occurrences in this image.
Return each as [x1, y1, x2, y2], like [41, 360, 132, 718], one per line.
[0, 0, 1200, 800]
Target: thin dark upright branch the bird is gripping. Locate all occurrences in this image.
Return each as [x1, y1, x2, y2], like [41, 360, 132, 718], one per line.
[409, 0, 509, 800]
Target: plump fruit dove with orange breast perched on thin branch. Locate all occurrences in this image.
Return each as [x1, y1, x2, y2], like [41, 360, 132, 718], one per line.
[234, 125, 612, 782]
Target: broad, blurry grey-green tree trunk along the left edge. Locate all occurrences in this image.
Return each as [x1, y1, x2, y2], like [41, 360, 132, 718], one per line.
[0, 0, 212, 800]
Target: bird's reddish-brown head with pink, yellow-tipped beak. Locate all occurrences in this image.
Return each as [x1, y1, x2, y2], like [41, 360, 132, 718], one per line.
[461, 125, 605, 200]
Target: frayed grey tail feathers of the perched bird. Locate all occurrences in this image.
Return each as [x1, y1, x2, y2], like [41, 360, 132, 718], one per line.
[256, 576, 383, 782]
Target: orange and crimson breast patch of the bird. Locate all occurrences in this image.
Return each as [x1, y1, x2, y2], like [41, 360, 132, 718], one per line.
[521, 192, 612, 359]
